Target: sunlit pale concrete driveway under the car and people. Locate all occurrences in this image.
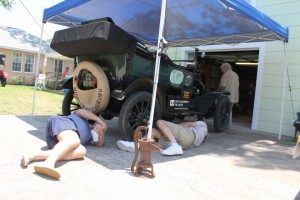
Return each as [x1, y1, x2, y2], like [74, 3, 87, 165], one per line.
[0, 115, 300, 200]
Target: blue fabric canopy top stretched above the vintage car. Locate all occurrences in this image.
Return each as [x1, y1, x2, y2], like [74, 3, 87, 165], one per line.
[43, 0, 288, 46]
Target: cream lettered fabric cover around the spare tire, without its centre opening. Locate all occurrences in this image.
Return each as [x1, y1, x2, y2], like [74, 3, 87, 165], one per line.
[73, 61, 110, 115]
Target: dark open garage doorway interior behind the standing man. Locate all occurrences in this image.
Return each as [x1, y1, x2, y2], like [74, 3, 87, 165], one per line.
[201, 50, 259, 128]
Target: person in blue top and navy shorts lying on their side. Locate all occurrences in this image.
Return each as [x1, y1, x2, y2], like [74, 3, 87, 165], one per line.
[21, 109, 107, 179]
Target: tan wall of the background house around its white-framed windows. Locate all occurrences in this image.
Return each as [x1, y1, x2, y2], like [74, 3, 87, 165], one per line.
[0, 48, 45, 85]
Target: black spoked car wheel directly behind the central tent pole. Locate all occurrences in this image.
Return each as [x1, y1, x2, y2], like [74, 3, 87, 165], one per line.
[119, 91, 161, 141]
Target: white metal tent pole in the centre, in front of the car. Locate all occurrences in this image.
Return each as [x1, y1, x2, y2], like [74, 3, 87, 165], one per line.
[147, 0, 167, 139]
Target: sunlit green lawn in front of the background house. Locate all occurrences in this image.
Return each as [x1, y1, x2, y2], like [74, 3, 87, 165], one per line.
[0, 85, 64, 115]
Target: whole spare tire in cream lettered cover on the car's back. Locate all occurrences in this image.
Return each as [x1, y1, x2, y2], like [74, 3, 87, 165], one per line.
[73, 61, 110, 115]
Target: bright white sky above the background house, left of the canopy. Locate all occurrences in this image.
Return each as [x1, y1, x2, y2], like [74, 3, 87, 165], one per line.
[0, 0, 65, 40]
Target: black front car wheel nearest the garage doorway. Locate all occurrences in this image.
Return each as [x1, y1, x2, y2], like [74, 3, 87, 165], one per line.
[214, 96, 230, 133]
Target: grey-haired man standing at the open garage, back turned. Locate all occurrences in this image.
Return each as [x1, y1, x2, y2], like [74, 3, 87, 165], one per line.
[217, 63, 239, 128]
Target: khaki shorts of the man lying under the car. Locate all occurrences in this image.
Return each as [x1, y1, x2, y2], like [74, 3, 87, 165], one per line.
[158, 122, 195, 149]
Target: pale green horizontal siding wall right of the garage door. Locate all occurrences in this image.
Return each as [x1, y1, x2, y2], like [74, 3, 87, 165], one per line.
[256, 0, 300, 136]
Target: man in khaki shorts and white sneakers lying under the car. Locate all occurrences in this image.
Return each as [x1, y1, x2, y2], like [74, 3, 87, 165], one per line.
[117, 120, 208, 156]
